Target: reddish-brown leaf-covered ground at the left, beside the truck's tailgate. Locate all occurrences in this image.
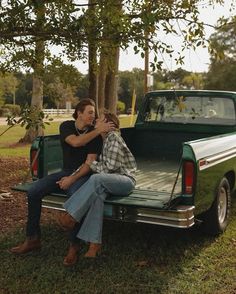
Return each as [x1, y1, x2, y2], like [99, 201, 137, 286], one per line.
[0, 157, 55, 233]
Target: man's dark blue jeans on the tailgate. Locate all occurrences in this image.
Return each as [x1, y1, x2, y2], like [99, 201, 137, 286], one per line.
[26, 170, 89, 237]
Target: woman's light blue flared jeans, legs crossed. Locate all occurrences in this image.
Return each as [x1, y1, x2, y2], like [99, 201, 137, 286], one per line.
[64, 173, 135, 243]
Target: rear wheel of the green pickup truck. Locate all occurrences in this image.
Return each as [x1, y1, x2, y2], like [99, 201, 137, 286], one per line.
[204, 178, 231, 235]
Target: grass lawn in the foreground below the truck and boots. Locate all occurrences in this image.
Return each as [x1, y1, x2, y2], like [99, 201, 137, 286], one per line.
[0, 202, 236, 294]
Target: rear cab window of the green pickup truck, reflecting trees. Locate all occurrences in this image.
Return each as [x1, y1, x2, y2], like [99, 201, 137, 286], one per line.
[145, 95, 235, 125]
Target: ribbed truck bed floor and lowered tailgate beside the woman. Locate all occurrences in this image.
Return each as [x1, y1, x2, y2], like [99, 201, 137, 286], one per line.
[102, 158, 181, 209]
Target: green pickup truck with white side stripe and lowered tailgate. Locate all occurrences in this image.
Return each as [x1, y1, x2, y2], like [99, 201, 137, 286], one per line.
[14, 90, 236, 234]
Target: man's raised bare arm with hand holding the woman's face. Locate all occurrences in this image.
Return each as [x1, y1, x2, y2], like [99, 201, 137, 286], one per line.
[65, 121, 114, 147]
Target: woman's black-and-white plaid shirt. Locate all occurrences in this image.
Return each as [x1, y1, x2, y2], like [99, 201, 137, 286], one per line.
[90, 131, 137, 180]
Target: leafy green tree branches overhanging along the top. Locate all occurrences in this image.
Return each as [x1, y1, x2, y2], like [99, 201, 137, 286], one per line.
[0, 0, 223, 71]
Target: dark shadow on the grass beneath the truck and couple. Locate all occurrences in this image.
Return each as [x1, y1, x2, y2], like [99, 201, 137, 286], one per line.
[0, 221, 223, 294]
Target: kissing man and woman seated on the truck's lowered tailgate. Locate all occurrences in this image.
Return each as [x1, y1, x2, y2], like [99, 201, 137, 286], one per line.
[10, 99, 136, 266]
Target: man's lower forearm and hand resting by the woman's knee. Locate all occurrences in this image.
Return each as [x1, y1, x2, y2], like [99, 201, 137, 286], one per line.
[57, 154, 97, 190]
